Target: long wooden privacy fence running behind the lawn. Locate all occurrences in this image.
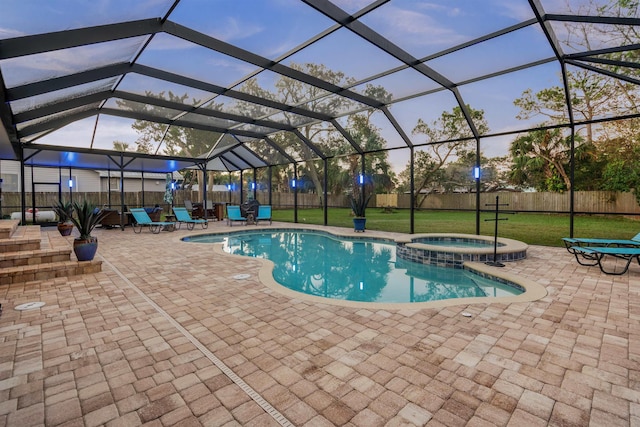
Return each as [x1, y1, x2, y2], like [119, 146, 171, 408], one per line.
[1, 190, 640, 215]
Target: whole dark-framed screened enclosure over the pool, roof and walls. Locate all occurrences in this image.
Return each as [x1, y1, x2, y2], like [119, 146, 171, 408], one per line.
[0, 0, 640, 234]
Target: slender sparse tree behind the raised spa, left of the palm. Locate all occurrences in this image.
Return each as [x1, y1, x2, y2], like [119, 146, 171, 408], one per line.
[400, 106, 489, 206]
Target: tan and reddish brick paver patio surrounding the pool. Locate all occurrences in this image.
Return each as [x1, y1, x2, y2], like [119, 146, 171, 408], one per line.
[0, 223, 640, 427]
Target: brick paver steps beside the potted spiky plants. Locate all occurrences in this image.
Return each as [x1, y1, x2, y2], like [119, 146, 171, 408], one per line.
[0, 226, 102, 285]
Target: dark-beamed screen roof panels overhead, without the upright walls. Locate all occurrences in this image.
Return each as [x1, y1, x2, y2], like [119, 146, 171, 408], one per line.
[0, 0, 640, 172]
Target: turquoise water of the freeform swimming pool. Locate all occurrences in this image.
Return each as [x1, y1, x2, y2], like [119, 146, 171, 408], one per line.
[184, 231, 522, 303]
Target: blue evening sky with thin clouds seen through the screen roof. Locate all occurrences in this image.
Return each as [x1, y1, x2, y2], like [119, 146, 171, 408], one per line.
[0, 0, 612, 175]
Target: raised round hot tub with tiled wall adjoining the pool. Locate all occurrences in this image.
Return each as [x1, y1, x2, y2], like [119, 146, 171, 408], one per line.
[396, 233, 528, 268]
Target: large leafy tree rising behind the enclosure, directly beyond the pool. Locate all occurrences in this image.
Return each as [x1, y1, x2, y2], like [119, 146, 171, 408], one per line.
[237, 63, 392, 203]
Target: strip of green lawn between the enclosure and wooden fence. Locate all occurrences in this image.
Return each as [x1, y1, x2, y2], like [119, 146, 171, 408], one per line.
[273, 208, 640, 246]
